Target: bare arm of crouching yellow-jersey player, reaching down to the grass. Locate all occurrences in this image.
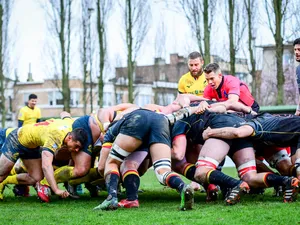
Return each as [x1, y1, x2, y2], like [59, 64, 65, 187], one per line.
[42, 148, 69, 198]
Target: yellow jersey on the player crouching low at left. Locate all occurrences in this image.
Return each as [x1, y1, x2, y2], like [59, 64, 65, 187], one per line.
[18, 118, 73, 153]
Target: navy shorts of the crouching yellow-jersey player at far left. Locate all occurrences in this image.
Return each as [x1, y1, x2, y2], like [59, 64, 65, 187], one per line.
[1, 129, 41, 163]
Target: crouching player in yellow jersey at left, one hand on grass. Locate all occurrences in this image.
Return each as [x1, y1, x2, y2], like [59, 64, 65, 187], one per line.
[0, 119, 87, 199]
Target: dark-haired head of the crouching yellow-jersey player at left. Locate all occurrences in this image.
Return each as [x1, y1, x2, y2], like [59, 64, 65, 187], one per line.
[64, 128, 87, 152]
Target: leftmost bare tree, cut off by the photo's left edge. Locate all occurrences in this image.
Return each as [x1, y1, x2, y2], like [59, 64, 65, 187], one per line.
[0, 0, 14, 127]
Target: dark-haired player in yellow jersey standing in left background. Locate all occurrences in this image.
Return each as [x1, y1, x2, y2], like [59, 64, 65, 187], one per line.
[18, 94, 41, 127]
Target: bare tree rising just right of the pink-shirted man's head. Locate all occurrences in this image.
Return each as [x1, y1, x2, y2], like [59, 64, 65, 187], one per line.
[225, 0, 246, 75]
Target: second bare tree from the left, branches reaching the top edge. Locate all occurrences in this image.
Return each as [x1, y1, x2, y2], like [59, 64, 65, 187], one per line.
[42, 0, 73, 111]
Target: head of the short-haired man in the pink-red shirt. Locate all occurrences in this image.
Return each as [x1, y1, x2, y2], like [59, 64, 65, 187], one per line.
[204, 63, 222, 89]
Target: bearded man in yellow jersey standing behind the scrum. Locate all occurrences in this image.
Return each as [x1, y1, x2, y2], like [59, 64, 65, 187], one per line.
[178, 52, 207, 96]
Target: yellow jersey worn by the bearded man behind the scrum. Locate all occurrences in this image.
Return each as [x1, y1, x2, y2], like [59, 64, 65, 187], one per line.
[178, 72, 207, 96]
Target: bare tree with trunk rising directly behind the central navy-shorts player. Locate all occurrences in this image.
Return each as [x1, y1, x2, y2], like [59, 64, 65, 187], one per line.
[124, 0, 151, 103]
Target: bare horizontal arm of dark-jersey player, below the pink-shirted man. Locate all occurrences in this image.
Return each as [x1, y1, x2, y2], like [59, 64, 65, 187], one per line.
[202, 125, 254, 140]
